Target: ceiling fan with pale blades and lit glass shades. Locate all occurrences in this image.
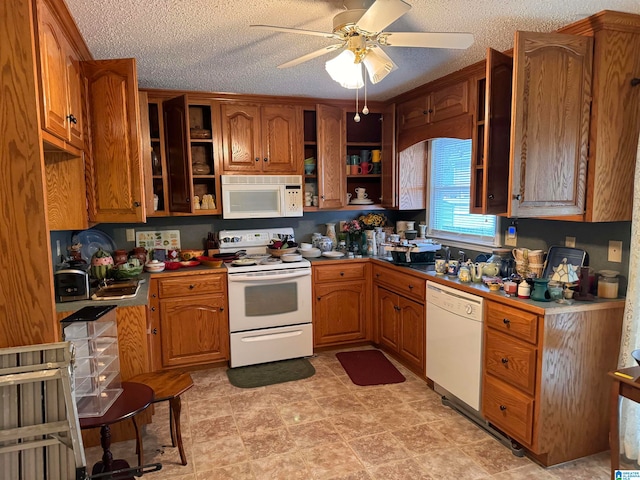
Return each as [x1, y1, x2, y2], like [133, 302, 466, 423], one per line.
[251, 0, 473, 88]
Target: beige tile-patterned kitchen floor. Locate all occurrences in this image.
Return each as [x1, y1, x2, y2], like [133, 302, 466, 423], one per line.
[87, 352, 609, 480]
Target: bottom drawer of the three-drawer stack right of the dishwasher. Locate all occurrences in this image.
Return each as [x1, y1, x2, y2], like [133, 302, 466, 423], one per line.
[482, 375, 534, 445]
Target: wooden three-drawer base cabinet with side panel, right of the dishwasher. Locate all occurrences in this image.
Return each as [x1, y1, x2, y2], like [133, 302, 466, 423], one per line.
[482, 299, 623, 466]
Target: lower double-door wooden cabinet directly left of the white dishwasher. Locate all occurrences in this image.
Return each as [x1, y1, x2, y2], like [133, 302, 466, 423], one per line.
[373, 265, 426, 377]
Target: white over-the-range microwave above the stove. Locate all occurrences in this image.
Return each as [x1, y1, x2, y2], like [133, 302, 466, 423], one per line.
[220, 175, 304, 218]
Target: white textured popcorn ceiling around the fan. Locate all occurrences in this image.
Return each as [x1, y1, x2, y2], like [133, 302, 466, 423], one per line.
[66, 0, 640, 100]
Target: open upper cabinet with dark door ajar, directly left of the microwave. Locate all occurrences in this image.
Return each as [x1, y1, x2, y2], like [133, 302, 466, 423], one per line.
[162, 95, 222, 215]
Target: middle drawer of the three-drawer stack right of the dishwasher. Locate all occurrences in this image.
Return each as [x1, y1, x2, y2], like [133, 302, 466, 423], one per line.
[484, 328, 537, 395]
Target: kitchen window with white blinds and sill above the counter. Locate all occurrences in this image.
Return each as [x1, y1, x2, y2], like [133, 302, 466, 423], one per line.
[427, 138, 500, 247]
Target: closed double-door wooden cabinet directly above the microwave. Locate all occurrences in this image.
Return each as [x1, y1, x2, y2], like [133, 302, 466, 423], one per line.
[221, 102, 304, 175]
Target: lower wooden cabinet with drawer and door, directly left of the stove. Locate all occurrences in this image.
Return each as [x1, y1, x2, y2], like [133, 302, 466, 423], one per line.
[150, 272, 229, 370]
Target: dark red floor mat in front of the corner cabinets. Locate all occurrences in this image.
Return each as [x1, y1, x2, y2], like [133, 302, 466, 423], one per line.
[336, 350, 406, 387]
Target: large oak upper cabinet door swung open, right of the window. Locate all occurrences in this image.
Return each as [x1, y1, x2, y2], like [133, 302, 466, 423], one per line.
[507, 32, 593, 217]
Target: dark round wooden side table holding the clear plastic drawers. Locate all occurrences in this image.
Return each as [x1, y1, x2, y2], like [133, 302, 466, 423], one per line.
[80, 382, 153, 475]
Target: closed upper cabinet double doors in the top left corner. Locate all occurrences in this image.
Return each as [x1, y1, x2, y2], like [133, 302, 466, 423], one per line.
[37, 0, 84, 150]
